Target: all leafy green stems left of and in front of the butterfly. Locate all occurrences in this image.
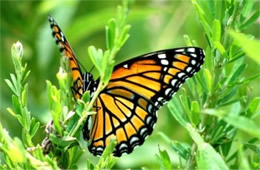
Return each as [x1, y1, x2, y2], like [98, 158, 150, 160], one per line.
[0, 0, 130, 169]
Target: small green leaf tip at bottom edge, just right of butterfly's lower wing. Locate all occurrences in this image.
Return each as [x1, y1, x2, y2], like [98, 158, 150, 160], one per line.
[155, 147, 172, 169]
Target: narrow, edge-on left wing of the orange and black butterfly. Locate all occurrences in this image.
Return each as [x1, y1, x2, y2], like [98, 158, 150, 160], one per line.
[49, 16, 83, 99]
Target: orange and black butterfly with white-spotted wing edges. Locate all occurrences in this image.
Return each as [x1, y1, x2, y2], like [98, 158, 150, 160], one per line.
[49, 16, 205, 157]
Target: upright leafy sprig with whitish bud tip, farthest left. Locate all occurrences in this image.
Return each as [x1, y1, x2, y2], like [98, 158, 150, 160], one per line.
[5, 42, 37, 147]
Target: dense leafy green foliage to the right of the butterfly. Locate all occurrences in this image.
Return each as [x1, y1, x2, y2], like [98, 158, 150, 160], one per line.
[168, 0, 260, 169]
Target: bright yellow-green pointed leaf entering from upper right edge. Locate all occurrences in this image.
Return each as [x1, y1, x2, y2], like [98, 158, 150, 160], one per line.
[228, 30, 260, 65]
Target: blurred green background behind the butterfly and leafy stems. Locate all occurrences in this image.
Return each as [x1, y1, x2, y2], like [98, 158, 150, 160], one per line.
[0, 0, 260, 168]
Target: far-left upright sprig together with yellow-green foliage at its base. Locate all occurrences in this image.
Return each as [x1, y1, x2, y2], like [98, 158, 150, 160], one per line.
[0, 42, 58, 169]
